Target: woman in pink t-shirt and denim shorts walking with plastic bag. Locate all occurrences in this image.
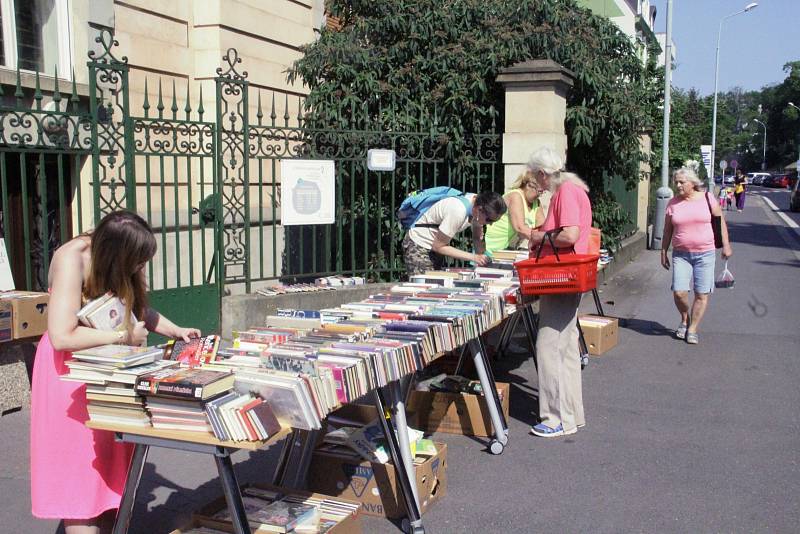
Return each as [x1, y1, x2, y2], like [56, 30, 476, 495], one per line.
[661, 167, 733, 345]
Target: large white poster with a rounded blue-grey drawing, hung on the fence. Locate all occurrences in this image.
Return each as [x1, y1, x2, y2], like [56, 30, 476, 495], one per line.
[281, 159, 336, 226]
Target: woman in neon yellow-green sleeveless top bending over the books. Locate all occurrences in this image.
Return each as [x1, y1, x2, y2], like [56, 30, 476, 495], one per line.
[485, 172, 544, 252]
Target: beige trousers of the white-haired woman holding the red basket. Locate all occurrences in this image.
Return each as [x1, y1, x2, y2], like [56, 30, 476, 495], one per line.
[536, 293, 586, 436]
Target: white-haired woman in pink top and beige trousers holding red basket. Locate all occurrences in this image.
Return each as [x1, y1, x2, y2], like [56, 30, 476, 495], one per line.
[528, 148, 592, 438]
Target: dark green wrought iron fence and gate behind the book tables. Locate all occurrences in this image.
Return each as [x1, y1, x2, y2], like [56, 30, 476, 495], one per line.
[0, 32, 503, 330]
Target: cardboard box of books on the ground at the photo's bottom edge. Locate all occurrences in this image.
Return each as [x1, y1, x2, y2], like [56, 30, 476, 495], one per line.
[191, 484, 361, 534]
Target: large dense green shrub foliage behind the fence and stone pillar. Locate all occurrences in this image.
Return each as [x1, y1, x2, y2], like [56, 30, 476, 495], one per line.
[289, 0, 659, 247]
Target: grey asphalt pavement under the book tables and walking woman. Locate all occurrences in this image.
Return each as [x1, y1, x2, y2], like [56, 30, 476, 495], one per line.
[0, 197, 800, 534]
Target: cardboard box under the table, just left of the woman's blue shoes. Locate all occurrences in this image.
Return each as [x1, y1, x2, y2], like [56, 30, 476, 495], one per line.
[406, 382, 511, 437]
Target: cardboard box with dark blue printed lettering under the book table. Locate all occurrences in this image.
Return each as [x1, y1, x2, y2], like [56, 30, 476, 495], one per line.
[308, 405, 447, 519]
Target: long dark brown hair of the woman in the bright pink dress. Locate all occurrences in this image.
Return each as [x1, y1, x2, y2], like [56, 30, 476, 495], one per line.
[84, 210, 157, 329]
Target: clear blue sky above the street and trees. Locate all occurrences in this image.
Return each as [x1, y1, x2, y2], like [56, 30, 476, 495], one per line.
[650, 0, 800, 95]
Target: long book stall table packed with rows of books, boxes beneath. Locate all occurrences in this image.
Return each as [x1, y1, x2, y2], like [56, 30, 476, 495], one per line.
[62, 263, 516, 533]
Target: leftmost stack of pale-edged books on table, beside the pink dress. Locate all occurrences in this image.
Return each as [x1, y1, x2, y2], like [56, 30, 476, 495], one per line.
[61, 345, 178, 427]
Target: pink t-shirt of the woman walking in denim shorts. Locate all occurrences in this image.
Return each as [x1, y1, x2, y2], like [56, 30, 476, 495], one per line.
[667, 193, 717, 252]
